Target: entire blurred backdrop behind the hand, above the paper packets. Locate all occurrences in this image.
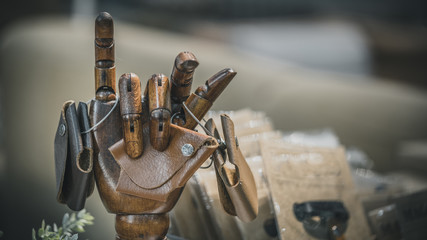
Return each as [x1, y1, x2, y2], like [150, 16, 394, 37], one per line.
[0, 0, 427, 239]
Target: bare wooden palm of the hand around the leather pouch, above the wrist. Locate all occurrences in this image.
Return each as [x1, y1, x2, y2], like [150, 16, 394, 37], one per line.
[90, 100, 182, 215]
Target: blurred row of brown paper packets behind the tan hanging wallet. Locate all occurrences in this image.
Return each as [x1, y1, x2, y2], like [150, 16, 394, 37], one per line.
[170, 109, 426, 240]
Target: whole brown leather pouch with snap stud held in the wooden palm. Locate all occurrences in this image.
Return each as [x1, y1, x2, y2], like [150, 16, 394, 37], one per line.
[109, 124, 218, 202]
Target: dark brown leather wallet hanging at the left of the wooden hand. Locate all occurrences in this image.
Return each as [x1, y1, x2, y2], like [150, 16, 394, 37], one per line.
[54, 101, 94, 211]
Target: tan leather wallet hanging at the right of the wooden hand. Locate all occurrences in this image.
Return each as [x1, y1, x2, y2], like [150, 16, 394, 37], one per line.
[206, 114, 258, 222]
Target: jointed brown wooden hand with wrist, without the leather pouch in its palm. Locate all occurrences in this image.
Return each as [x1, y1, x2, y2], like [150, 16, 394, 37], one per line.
[89, 13, 236, 239]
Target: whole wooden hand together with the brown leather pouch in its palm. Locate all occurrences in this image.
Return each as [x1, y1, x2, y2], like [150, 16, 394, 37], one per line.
[89, 13, 236, 239]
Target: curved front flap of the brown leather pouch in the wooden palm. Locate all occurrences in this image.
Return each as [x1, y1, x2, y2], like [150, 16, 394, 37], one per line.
[109, 124, 214, 189]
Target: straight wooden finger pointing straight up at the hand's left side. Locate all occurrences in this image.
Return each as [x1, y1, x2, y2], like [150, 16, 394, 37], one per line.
[95, 12, 116, 101]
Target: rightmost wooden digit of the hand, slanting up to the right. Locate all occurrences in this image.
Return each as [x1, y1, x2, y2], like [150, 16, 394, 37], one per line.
[175, 68, 237, 129]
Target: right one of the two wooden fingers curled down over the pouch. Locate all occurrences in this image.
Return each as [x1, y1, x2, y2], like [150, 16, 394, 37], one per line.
[146, 74, 171, 151]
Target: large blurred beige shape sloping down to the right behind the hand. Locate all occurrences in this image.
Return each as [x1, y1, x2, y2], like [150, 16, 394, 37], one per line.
[0, 15, 427, 239]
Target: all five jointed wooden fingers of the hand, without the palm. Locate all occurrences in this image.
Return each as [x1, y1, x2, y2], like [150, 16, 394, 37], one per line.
[95, 13, 236, 158]
